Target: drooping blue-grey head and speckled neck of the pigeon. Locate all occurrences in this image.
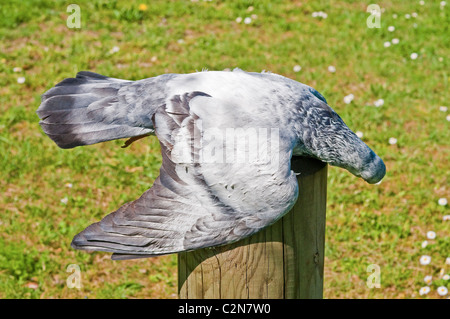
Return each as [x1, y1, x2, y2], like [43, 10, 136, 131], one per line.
[294, 92, 386, 184]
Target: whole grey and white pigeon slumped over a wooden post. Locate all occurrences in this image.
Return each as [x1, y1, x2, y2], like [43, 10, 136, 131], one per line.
[37, 69, 386, 260]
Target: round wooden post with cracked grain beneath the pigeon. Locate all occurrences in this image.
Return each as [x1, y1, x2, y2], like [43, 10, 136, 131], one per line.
[178, 158, 327, 299]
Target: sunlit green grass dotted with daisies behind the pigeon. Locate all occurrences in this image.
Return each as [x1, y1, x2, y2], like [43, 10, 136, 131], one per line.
[0, 0, 450, 298]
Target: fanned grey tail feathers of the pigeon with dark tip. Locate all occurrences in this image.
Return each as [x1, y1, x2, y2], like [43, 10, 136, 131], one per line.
[37, 72, 153, 148]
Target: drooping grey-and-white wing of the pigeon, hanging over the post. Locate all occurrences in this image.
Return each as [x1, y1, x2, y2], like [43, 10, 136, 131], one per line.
[72, 92, 298, 259]
